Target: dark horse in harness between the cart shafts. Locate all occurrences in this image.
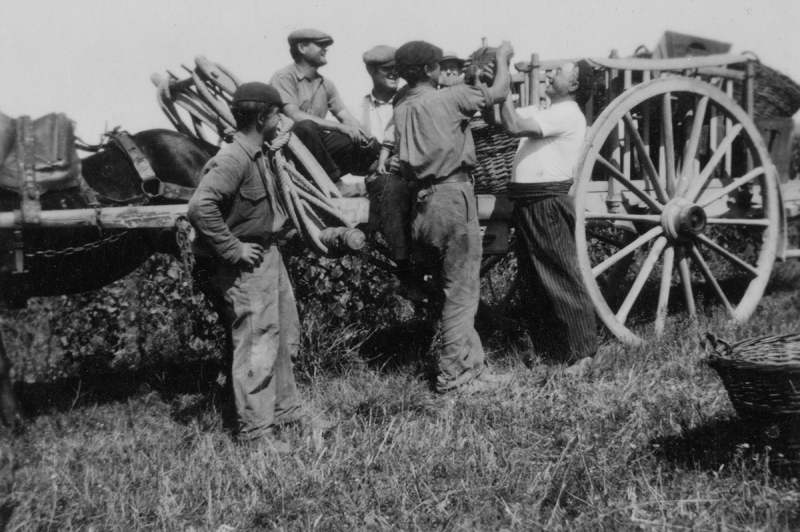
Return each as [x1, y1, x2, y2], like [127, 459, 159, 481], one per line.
[0, 129, 212, 428]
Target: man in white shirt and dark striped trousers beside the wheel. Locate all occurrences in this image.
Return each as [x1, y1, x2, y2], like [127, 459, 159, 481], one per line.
[501, 61, 597, 373]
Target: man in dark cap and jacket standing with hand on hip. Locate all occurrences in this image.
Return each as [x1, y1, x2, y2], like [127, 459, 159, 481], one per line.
[189, 82, 325, 452]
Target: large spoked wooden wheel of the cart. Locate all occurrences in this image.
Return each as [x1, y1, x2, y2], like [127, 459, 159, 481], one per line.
[575, 77, 781, 344]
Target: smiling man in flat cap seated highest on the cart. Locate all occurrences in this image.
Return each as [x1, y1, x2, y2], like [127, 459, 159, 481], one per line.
[270, 29, 380, 181]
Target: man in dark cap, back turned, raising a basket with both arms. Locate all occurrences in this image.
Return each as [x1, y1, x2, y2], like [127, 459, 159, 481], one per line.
[394, 41, 513, 393]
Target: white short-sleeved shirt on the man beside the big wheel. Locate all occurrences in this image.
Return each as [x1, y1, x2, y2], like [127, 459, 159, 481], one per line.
[511, 100, 586, 183]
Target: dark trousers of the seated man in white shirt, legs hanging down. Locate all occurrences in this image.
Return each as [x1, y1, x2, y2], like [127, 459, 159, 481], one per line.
[364, 174, 412, 261]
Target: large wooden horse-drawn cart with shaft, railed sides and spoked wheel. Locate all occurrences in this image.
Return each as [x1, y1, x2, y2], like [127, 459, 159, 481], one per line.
[17, 50, 800, 344]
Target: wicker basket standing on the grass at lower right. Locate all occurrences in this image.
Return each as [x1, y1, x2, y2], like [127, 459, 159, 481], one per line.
[707, 333, 800, 464]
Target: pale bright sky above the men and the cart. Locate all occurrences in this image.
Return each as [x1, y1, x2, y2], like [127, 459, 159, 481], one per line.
[0, 0, 800, 142]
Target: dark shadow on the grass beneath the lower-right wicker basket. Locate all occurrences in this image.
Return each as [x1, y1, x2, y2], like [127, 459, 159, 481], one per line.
[650, 417, 800, 477]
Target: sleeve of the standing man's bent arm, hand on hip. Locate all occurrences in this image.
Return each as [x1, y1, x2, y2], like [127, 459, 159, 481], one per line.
[188, 156, 246, 264]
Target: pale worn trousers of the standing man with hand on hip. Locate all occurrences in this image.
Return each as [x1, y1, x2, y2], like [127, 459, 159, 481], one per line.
[193, 246, 300, 440]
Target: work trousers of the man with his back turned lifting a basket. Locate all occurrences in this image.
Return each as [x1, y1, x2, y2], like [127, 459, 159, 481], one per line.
[411, 182, 486, 392]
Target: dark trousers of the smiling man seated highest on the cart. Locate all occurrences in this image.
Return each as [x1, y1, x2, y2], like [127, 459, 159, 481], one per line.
[292, 120, 381, 182]
